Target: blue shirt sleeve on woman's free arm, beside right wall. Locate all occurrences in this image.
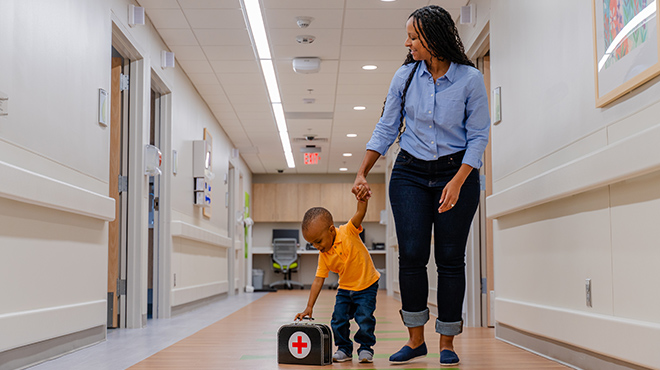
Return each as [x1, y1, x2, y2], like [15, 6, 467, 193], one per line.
[463, 72, 490, 168]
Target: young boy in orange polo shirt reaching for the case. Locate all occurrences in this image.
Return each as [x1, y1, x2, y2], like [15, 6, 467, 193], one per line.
[296, 195, 380, 363]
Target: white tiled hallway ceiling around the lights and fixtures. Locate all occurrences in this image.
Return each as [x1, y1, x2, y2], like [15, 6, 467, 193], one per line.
[137, 0, 467, 174]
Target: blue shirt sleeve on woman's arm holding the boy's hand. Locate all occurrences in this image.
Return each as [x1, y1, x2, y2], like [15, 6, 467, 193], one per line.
[367, 67, 407, 155]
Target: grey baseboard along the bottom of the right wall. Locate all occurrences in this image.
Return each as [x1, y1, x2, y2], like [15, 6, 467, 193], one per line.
[495, 323, 652, 370]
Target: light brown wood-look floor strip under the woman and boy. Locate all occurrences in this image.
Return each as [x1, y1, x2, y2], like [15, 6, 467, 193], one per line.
[130, 290, 569, 370]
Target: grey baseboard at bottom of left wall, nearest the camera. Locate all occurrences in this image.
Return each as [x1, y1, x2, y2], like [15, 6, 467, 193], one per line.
[0, 325, 106, 370]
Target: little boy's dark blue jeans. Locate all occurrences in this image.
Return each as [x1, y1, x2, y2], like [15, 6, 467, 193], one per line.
[330, 282, 378, 355]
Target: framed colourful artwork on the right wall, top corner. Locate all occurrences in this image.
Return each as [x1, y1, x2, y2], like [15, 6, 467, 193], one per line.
[592, 0, 660, 107]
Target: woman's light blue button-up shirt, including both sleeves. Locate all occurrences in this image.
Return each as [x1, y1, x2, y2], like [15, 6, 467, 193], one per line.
[367, 62, 490, 168]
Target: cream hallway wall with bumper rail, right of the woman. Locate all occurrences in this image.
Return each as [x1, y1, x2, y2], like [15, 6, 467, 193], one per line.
[487, 0, 660, 368]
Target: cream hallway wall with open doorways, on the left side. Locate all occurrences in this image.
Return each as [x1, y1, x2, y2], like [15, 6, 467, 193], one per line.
[0, 0, 251, 368]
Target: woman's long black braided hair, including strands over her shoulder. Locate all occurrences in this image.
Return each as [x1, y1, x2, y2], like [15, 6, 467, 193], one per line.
[381, 5, 474, 141]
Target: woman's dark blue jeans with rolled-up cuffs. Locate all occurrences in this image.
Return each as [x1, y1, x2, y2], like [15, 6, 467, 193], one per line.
[389, 150, 480, 335]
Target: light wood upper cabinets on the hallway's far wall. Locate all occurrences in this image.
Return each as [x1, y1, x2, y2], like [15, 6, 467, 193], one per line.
[252, 183, 386, 222]
